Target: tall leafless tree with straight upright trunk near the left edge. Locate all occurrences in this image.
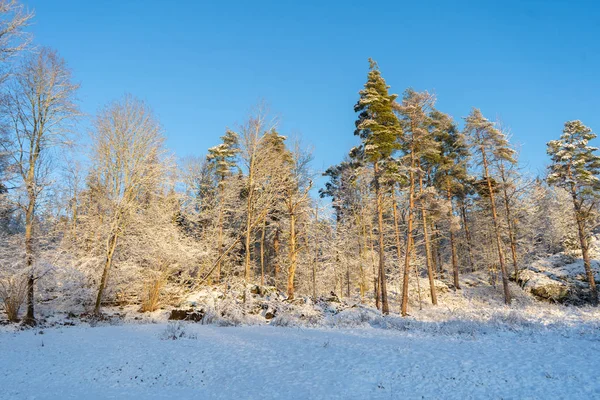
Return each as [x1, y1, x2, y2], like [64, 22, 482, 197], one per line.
[0, 47, 80, 323]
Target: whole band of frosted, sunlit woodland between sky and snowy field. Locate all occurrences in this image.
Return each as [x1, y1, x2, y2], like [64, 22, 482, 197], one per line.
[0, 1, 600, 325]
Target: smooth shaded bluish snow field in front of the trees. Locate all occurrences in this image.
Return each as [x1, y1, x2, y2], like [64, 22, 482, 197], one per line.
[0, 322, 600, 400]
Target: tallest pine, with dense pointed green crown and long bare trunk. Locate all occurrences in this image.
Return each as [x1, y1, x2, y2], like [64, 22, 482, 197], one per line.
[354, 59, 401, 314]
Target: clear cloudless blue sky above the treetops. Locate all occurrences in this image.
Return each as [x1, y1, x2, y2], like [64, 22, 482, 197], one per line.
[23, 0, 600, 178]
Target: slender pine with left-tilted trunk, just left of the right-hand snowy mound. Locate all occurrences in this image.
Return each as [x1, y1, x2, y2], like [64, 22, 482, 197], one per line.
[464, 108, 516, 304]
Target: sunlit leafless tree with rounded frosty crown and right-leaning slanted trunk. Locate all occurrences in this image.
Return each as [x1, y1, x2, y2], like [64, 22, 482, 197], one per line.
[90, 95, 165, 314]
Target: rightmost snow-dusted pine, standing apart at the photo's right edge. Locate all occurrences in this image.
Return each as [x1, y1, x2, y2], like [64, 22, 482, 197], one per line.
[547, 120, 600, 304]
